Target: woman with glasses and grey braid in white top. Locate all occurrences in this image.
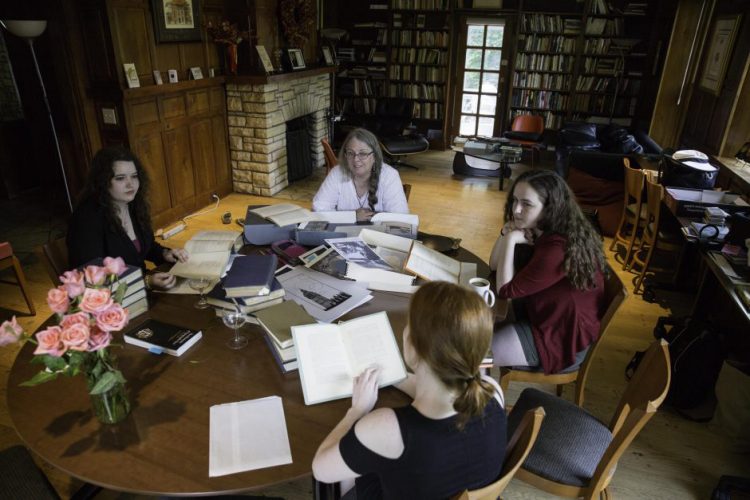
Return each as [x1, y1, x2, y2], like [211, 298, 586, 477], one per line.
[313, 128, 409, 221]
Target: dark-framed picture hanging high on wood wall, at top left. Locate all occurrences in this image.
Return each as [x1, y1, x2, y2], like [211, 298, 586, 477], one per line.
[151, 0, 201, 43]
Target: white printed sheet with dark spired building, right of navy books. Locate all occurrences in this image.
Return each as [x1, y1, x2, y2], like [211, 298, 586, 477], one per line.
[276, 266, 372, 323]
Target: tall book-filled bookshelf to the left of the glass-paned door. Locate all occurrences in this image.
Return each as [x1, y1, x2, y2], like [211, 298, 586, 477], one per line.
[335, 0, 452, 149]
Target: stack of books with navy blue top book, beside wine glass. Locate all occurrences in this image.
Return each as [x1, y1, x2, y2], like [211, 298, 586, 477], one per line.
[206, 255, 284, 316]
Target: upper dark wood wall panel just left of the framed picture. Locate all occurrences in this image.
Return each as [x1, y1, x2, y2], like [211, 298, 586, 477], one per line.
[110, 2, 154, 84]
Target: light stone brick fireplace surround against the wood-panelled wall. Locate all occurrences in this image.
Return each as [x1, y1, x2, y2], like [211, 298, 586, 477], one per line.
[227, 71, 330, 196]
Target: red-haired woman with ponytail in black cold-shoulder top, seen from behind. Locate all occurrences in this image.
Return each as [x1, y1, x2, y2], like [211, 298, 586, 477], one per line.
[312, 281, 507, 500]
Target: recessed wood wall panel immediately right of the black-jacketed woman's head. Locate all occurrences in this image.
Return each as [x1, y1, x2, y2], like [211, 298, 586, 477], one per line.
[131, 129, 172, 215]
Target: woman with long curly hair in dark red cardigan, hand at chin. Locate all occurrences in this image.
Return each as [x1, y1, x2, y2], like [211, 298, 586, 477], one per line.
[490, 170, 607, 373]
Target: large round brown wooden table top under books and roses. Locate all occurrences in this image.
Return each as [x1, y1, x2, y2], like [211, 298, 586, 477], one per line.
[8, 250, 496, 496]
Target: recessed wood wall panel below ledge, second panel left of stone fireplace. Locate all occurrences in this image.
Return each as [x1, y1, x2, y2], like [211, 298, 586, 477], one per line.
[162, 125, 195, 212]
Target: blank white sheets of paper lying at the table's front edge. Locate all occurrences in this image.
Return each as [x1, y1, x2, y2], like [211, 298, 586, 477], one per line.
[208, 396, 292, 477]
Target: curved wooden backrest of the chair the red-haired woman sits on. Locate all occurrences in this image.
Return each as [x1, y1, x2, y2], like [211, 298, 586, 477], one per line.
[454, 408, 544, 500]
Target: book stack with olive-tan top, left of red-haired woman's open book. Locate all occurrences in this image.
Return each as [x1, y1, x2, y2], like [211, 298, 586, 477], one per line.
[255, 300, 316, 373]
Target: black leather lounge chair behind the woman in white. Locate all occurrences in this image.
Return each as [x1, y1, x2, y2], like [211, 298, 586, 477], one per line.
[364, 97, 430, 169]
